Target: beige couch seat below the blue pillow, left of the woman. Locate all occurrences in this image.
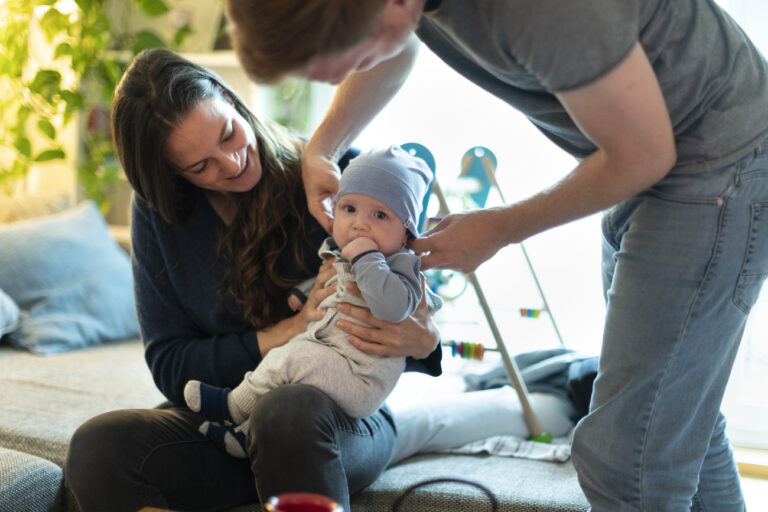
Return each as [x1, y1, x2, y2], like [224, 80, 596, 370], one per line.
[0, 340, 164, 466]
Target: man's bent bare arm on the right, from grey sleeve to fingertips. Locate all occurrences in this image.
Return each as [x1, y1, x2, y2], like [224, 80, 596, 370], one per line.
[411, 44, 677, 271]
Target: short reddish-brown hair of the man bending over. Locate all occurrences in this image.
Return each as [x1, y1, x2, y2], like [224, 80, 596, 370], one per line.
[227, 0, 386, 83]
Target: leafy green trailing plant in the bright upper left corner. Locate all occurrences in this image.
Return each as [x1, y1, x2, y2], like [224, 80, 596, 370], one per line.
[0, 0, 201, 217]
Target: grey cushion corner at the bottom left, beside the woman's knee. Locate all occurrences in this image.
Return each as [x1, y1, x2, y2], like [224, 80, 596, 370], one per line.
[0, 447, 61, 512]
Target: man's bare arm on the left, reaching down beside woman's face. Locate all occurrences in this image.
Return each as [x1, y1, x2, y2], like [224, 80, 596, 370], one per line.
[302, 35, 420, 232]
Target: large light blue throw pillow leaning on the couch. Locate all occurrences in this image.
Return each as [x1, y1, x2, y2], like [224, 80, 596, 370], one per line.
[0, 202, 139, 355]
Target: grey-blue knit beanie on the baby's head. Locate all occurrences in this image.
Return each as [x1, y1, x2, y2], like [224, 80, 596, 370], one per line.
[336, 146, 432, 237]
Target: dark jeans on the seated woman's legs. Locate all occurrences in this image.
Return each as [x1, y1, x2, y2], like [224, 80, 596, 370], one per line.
[64, 384, 395, 512]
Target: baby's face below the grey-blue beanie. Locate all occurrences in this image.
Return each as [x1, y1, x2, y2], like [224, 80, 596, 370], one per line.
[332, 194, 408, 256]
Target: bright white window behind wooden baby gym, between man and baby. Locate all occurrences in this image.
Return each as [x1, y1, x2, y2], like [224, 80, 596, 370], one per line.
[356, 48, 605, 354]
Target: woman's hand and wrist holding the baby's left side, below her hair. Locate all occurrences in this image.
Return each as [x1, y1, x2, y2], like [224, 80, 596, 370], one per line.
[258, 260, 336, 357]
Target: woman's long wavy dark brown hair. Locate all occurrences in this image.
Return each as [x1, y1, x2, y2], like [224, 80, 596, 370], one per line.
[111, 49, 311, 329]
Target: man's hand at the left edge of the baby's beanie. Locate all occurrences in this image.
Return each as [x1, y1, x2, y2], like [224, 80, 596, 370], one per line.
[301, 149, 341, 233]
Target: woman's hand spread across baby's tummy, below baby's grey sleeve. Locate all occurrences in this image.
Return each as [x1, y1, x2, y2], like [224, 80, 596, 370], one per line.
[337, 276, 440, 359]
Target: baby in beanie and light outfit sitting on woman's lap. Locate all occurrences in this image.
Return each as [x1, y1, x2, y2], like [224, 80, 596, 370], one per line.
[184, 146, 440, 457]
